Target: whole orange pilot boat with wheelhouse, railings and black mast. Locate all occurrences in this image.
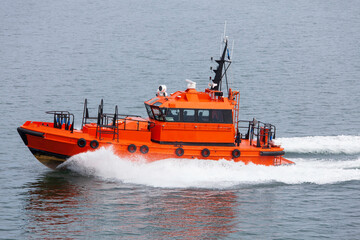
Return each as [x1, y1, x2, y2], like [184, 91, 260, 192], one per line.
[17, 36, 293, 169]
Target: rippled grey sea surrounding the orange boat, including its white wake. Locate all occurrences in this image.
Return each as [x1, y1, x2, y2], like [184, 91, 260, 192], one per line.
[0, 0, 360, 239]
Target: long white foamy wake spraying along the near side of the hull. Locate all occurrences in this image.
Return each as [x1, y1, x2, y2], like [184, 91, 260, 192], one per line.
[63, 148, 360, 188]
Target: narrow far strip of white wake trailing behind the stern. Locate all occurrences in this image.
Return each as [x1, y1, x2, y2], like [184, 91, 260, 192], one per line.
[275, 135, 360, 154]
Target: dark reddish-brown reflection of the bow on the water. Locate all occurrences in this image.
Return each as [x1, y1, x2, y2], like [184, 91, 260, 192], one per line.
[25, 172, 93, 237]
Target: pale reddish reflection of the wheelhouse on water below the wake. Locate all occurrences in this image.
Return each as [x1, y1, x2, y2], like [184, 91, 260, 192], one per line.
[142, 190, 237, 238]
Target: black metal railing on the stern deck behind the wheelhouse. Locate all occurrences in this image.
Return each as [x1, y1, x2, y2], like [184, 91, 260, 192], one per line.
[236, 118, 276, 148]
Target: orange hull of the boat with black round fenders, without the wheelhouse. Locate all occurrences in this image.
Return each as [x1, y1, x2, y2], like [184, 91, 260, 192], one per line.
[18, 121, 293, 169]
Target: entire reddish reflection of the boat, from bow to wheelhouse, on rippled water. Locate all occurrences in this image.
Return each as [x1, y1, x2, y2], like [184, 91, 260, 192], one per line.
[24, 172, 238, 238]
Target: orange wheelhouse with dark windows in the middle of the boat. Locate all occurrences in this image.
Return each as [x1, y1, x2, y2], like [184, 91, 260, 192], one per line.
[145, 88, 237, 145]
